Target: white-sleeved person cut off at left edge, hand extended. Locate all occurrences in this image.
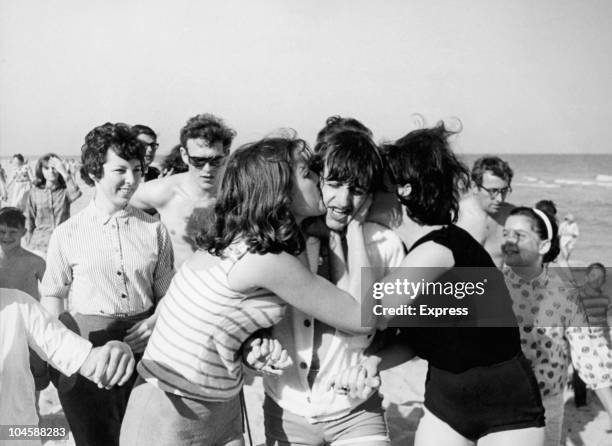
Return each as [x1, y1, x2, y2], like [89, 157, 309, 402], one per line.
[0, 288, 134, 446]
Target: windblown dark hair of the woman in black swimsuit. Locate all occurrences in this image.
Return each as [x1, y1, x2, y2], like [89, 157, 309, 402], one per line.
[382, 123, 469, 225]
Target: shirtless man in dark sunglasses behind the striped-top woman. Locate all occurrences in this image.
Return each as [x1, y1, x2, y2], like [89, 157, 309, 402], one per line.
[131, 114, 236, 268]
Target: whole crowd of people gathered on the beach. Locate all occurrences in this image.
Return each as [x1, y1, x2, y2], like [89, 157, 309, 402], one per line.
[0, 114, 612, 446]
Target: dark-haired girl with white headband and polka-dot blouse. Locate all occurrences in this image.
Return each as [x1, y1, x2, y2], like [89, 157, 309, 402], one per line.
[502, 207, 612, 446]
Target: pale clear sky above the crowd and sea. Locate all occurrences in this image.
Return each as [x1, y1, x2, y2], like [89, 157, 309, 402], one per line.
[0, 0, 612, 156]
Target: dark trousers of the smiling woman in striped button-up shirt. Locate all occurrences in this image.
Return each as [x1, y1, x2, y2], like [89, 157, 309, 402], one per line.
[57, 312, 151, 446]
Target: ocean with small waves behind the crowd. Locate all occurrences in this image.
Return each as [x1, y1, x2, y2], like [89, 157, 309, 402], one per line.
[0, 154, 612, 267]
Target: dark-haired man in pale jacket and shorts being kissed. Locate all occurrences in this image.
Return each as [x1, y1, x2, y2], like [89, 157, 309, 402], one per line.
[246, 118, 404, 446]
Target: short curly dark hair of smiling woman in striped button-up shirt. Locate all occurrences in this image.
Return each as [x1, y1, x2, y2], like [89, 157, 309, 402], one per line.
[81, 122, 146, 186]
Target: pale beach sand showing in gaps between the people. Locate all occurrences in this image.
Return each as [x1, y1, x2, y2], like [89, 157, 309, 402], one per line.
[40, 183, 612, 446]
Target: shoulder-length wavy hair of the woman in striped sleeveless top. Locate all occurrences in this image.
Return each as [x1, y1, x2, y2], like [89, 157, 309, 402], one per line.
[198, 132, 311, 256]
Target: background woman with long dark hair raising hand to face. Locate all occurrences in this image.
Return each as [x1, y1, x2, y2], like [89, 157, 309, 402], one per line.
[25, 153, 82, 256]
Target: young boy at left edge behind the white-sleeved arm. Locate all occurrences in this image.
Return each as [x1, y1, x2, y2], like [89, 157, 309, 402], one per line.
[0, 207, 49, 398]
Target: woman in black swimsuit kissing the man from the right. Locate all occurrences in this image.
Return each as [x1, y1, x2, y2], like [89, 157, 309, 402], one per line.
[377, 124, 544, 446]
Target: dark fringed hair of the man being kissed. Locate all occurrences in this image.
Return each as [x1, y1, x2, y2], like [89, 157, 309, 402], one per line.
[312, 129, 384, 192]
